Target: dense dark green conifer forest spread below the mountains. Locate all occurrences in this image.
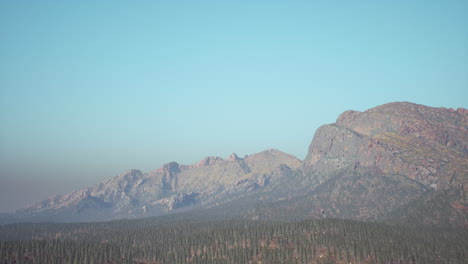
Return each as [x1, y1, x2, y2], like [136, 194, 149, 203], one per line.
[0, 217, 468, 264]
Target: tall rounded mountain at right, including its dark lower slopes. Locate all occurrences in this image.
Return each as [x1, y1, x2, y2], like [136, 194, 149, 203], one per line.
[296, 102, 468, 225]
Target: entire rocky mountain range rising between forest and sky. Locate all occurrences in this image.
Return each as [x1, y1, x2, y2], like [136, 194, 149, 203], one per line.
[4, 102, 468, 225]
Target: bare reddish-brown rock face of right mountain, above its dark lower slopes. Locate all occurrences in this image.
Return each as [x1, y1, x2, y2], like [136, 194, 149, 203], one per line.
[304, 103, 468, 189]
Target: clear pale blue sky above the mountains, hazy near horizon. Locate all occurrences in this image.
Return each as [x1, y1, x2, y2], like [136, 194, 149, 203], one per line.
[0, 0, 468, 212]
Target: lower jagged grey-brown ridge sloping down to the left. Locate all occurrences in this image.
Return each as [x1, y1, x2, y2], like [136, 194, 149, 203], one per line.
[19, 149, 301, 221]
